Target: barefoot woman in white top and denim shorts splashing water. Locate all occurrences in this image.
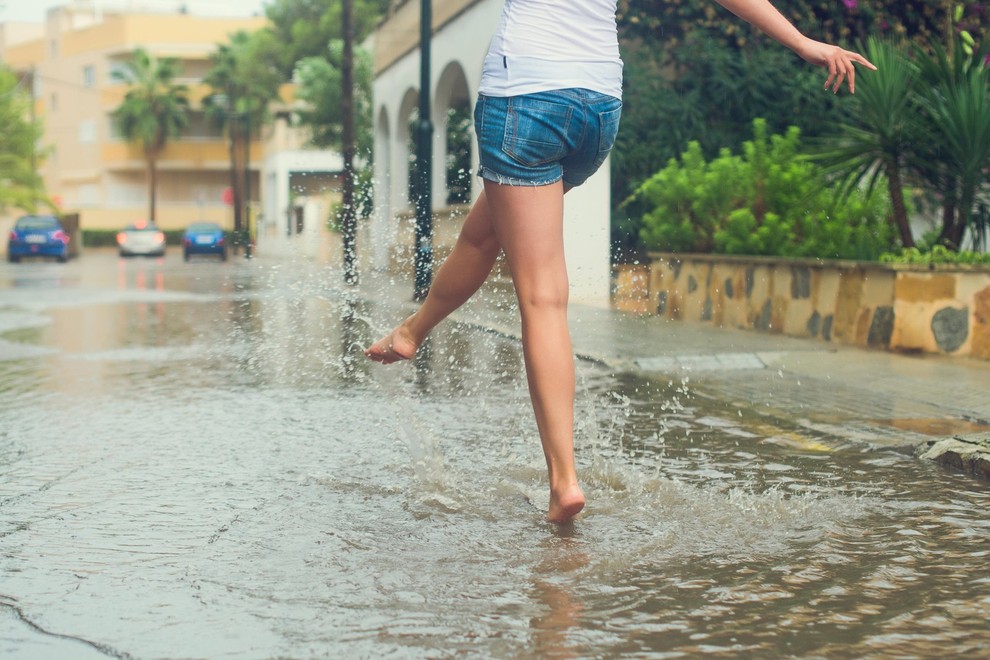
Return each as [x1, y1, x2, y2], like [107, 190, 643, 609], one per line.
[365, 0, 872, 522]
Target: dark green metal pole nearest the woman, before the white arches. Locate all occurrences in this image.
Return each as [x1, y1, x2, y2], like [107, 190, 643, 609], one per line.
[413, 0, 433, 301]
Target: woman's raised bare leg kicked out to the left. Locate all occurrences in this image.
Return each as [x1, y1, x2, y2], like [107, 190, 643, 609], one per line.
[364, 192, 500, 364]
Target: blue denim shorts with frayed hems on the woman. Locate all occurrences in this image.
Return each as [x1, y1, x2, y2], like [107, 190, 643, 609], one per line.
[474, 89, 622, 186]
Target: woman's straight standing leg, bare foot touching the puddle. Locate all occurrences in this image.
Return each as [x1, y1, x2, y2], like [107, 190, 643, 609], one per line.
[485, 181, 584, 522]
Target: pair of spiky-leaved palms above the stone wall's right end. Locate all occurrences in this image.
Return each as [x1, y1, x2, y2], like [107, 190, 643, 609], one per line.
[816, 39, 990, 249]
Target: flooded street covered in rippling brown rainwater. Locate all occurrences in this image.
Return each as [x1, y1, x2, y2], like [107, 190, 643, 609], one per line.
[0, 250, 990, 658]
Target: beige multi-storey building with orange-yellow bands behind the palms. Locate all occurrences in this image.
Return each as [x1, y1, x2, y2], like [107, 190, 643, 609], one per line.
[0, 3, 276, 235]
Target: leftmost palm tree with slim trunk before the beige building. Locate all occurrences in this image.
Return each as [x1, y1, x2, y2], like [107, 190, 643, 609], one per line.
[113, 48, 189, 223]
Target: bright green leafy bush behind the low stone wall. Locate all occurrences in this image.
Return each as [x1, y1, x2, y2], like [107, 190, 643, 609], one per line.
[636, 119, 894, 259]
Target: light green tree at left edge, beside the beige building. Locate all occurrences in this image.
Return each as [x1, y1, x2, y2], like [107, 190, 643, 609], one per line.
[0, 66, 50, 212]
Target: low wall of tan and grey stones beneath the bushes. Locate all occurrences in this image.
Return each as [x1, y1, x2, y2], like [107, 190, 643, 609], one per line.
[613, 253, 990, 360]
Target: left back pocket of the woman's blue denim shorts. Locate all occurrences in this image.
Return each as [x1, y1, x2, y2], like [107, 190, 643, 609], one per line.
[502, 96, 573, 167]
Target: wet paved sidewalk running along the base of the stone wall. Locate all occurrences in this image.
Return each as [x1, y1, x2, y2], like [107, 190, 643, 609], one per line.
[361, 276, 990, 470]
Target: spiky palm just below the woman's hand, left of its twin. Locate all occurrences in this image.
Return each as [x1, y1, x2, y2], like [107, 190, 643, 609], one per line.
[815, 37, 922, 247]
